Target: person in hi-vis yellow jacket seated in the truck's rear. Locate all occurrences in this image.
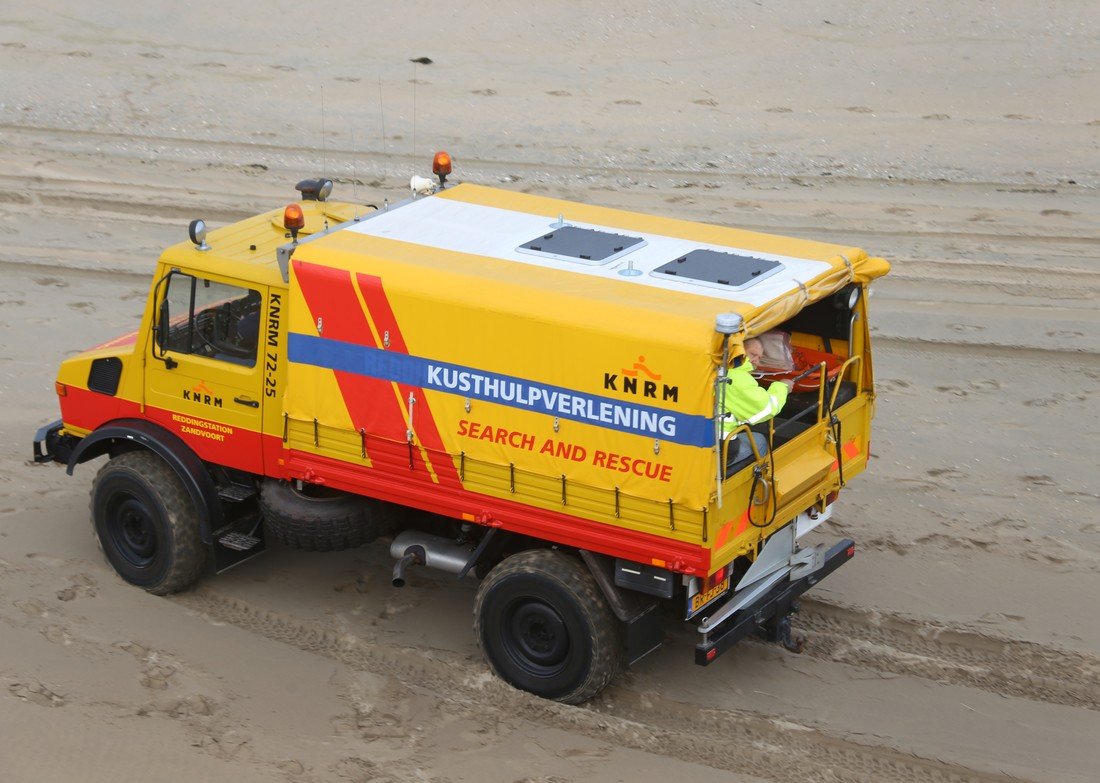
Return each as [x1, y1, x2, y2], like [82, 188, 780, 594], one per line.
[722, 338, 793, 472]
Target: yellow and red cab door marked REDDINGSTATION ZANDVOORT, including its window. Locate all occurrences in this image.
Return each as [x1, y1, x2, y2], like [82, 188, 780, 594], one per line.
[145, 269, 268, 474]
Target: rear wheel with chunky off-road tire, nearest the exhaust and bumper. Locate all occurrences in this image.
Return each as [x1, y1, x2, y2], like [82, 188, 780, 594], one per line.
[474, 549, 623, 704]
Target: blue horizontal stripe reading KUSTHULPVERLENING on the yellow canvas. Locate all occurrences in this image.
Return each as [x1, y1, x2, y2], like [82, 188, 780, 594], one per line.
[287, 332, 714, 448]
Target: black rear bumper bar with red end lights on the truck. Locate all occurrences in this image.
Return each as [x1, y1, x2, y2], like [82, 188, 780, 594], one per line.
[695, 539, 856, 666]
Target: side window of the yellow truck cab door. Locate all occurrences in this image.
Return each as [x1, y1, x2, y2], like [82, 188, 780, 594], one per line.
[157, 272, 261, 367]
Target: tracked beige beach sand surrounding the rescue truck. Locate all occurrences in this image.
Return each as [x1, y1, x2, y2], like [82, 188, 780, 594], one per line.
[0, 0, 1100, 783]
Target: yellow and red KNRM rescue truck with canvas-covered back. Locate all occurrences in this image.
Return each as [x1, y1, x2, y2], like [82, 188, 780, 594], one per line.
[34, 154, 889, 703]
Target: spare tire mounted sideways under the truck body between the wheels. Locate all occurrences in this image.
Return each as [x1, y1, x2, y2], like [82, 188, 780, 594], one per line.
[260, 478, 402, 552]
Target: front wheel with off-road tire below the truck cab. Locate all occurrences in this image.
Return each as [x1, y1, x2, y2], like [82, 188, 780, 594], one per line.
[91, 451, 207, 595]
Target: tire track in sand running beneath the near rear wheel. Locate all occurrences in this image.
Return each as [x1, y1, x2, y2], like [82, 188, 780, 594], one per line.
[168, 587, 1019, 783]
